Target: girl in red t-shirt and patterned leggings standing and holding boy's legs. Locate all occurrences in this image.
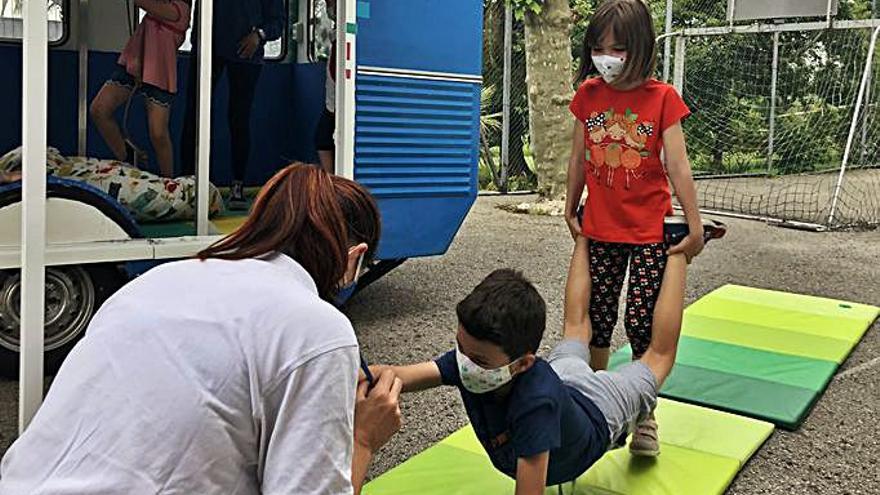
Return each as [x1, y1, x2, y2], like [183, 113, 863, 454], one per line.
[566, 0, 704, 456]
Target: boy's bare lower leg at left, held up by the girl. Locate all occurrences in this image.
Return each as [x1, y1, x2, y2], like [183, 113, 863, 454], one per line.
[563, 236, 593, 345]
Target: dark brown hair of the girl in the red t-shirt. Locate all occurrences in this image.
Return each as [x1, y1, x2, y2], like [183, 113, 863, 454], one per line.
[575, 0, 657, 86]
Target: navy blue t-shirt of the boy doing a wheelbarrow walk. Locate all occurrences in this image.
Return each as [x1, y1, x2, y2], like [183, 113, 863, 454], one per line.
[436, 350, 609, 486]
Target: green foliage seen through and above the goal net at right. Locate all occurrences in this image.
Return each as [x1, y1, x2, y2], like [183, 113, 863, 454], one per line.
[672, 0, 870, 174]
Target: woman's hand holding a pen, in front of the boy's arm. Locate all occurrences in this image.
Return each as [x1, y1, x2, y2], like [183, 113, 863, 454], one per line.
[354, 369, 403, 453]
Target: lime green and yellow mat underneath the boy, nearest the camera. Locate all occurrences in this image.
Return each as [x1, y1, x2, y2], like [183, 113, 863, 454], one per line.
[364, 399, 773, 495]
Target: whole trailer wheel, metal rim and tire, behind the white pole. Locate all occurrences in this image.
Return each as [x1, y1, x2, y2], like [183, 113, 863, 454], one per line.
[0, 264, 126, 378]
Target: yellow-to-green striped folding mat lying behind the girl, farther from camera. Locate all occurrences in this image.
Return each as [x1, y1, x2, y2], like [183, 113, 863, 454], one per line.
[611, 285, 880, 429]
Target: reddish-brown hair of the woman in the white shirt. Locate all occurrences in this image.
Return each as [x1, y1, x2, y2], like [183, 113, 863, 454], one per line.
[197, 163, 380, 301]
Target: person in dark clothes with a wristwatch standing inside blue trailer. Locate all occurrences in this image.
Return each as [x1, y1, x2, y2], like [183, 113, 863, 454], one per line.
[180, 0, 286, 210]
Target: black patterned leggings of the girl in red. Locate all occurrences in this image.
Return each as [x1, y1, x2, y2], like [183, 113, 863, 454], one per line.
[590, 239, 666, 359]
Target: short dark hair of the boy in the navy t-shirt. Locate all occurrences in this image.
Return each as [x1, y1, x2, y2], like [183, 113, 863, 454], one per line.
[455, 269, 547, 359]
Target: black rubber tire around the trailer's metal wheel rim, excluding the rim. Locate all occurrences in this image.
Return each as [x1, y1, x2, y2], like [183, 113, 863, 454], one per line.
[0, 263, 127, 379]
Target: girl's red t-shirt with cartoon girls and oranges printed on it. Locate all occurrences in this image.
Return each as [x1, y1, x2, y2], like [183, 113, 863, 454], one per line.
[569, 77, 690, 244]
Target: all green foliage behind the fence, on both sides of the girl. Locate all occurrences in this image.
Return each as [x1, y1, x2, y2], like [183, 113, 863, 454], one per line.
[480, 0, 880, 186]
